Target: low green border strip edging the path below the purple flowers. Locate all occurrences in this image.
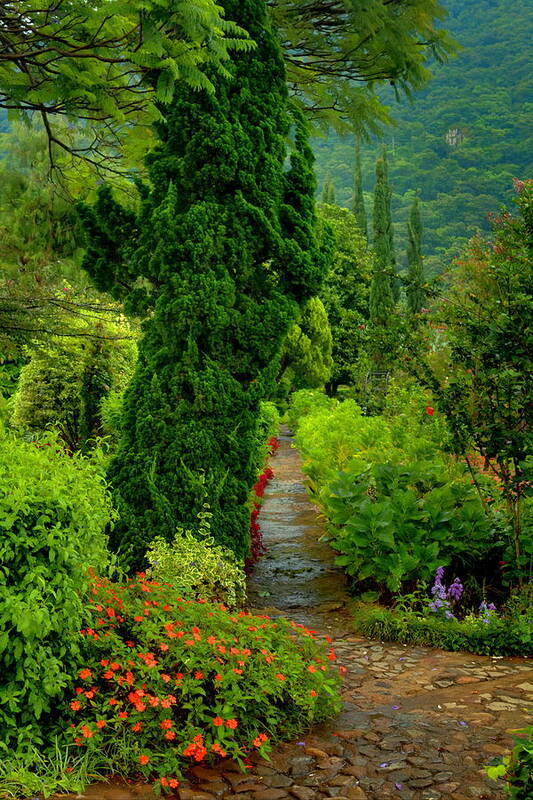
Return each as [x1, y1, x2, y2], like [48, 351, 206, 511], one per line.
[354, 603, 533, 656]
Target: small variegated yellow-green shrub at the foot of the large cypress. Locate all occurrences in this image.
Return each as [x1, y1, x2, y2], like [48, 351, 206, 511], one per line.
[146, 510, 246, 608]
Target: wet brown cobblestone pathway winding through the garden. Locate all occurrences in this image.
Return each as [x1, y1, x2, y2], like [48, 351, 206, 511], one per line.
[72, 431, 533, 800]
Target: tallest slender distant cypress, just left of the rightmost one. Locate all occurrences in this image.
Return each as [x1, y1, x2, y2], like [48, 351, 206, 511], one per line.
[370, 156, 395, 326]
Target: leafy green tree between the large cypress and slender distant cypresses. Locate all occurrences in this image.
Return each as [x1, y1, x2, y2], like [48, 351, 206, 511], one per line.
[319, 206, 374, 389]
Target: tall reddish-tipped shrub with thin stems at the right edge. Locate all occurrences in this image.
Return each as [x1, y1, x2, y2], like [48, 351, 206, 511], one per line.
[407, 181, 533, 581]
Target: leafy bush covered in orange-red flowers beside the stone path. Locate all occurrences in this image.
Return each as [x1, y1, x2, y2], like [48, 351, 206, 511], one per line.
[69, 574, 340, 786]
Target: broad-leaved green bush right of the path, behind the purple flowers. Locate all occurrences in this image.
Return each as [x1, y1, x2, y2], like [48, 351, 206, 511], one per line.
[323, 460, 491, 591]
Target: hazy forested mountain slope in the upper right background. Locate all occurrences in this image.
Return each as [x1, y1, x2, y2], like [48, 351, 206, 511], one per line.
[314, 0, 533, 270]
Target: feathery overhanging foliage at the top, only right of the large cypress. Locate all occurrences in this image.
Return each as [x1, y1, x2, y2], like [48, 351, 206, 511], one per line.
[269, 0, 455, 131]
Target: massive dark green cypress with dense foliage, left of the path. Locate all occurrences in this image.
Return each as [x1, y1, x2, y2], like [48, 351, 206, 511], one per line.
[78, 0, 325, 567]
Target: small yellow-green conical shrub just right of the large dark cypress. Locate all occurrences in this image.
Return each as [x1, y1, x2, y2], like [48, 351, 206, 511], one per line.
[280, 297, 333, 391]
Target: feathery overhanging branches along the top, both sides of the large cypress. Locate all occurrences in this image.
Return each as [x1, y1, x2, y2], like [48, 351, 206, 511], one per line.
[0, 0, 453, 169]
